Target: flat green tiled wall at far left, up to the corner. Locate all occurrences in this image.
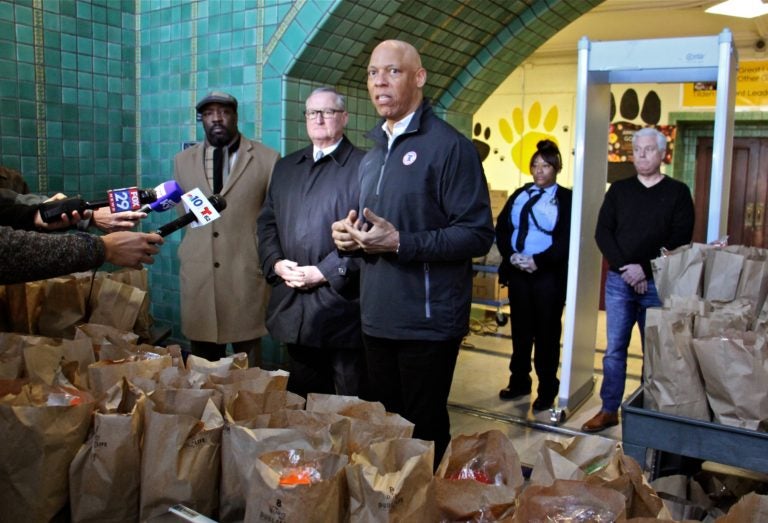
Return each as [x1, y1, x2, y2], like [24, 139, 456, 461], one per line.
[0, 0, 138, 198]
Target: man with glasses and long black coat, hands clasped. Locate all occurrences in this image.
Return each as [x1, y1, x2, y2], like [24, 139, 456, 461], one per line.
[258, 87, 366, 396]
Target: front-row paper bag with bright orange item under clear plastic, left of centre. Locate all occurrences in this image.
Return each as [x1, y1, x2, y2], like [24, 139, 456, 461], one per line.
[245, 450, 349, 523]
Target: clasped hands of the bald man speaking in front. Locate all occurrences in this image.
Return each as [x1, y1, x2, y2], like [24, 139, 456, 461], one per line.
[331, 208, 400, 254]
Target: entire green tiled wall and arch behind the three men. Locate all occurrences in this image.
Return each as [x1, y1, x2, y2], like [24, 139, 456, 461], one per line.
[0, 0, 624, 352]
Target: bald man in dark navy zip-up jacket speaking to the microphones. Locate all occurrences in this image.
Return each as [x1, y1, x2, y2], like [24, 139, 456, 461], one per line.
[332, 40, 494, 464]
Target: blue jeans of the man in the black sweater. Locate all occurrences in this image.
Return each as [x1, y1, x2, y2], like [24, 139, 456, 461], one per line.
[600, 271, 661, 412]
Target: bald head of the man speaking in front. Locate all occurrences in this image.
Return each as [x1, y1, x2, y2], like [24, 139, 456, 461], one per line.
[368, 40, 427, 129]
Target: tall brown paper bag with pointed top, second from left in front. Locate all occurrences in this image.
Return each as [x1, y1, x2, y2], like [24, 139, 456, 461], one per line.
[69, 378, 144, 523]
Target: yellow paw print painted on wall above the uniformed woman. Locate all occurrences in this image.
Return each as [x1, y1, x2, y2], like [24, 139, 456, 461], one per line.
[499, 102, 560, 175]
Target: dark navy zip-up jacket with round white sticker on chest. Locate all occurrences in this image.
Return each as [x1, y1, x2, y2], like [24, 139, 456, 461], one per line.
[360, 101, 494, 341]
